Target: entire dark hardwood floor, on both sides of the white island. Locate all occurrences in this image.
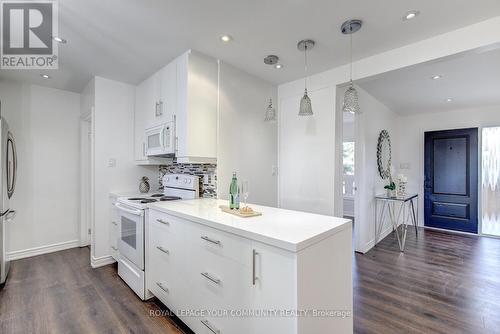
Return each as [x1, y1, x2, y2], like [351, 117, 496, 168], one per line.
[0, 230, 500, 334]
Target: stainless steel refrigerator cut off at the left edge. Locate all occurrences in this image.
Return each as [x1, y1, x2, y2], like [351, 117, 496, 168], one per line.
[0, 117, 17, 287]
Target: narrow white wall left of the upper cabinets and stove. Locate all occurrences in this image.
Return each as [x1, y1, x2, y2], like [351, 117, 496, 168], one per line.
[90, 77, 158, 266]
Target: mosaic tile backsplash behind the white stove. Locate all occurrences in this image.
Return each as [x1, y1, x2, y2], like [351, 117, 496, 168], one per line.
[158, 162, 217, 198]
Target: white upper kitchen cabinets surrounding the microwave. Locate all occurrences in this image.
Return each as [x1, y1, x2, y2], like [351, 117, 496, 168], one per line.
[135, 50, 219, 164]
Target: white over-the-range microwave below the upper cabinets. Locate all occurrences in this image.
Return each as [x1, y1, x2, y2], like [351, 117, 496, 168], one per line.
[146, 122, 175, 156]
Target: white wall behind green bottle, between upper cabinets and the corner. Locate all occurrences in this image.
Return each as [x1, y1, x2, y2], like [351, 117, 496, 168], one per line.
[217, 62, 278, 206]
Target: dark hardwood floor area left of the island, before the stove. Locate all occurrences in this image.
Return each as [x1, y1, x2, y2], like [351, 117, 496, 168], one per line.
[0, 248, 186, 334]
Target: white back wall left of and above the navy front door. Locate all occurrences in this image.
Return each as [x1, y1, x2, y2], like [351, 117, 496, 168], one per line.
[398, 106, 500, 226]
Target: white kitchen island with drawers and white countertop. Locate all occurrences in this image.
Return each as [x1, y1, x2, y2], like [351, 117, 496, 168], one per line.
[146, 199, 353, 334]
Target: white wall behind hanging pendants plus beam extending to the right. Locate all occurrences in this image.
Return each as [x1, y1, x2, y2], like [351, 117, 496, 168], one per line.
[278, 16, 500, 250]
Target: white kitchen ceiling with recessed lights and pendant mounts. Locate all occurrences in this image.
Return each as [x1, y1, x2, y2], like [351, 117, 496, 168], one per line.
[0, 0, 500, 92]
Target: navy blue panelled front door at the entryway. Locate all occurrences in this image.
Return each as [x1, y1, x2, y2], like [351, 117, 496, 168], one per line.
[424, 128, 478, 233]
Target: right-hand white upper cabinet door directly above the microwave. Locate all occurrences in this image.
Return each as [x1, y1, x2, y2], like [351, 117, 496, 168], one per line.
[158, 61, 177, 125]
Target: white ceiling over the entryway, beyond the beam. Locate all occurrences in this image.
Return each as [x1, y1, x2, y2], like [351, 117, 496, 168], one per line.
[357, 47, 500, 114]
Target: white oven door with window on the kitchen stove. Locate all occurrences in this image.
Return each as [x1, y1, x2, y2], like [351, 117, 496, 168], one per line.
[115, 203, 144, 270]
